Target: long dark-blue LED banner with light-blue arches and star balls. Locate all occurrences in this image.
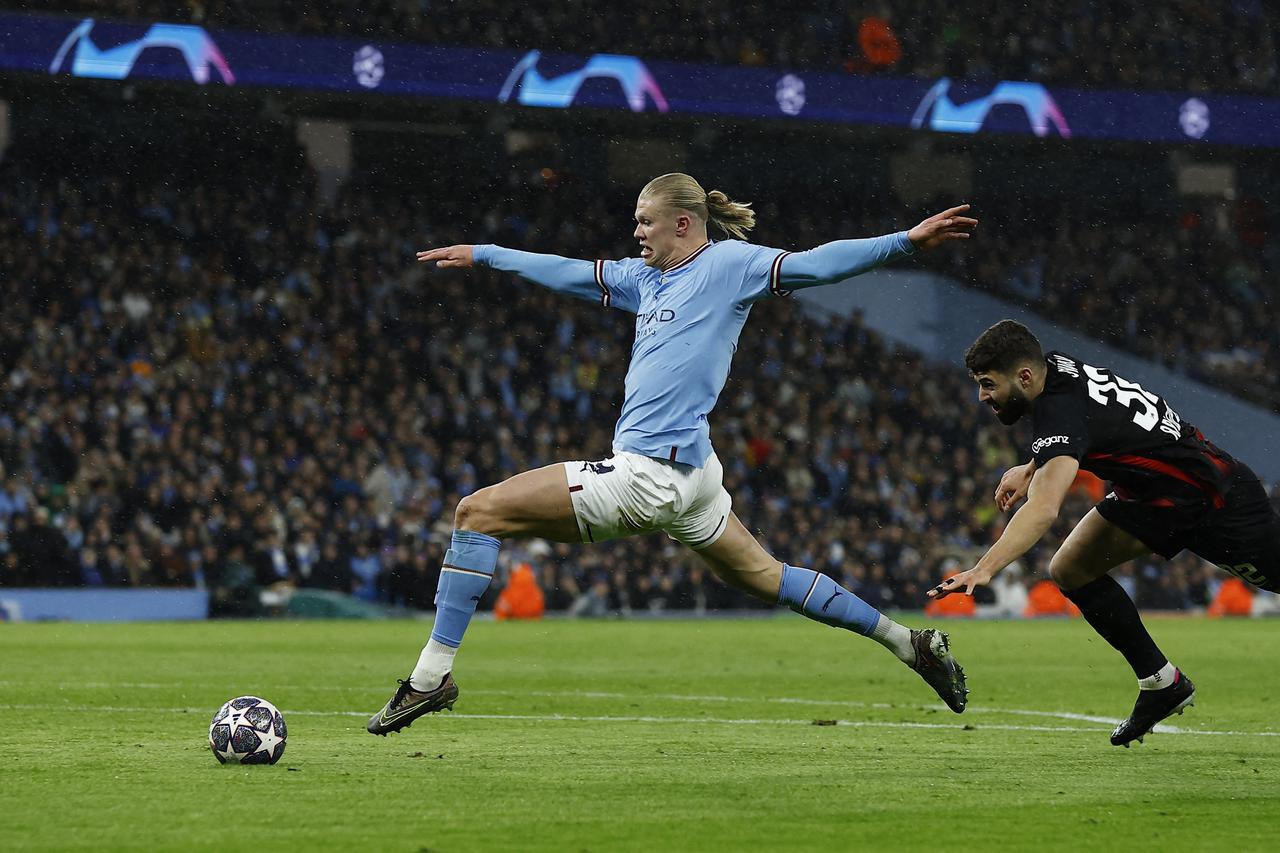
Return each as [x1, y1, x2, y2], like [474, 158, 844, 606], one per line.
[0, 15, 1280, 147]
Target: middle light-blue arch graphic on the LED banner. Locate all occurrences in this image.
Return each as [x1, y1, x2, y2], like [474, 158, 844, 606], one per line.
[498, 50, 667, 113]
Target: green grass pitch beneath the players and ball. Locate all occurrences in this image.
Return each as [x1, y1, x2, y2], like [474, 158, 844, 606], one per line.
[0, 615, 1280, 850]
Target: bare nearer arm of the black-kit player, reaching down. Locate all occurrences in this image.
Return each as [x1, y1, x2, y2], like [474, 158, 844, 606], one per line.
[928, 456, 1080, 598]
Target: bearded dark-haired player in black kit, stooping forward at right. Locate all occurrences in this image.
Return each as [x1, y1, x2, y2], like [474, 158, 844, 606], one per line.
[929, 320, 1280, 747]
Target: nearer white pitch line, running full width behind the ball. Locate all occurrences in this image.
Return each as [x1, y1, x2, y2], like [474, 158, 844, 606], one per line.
[0, 704, 1280, 738]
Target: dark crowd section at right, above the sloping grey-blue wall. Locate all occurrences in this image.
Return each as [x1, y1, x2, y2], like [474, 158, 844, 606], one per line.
[957, 196, 1280, 411]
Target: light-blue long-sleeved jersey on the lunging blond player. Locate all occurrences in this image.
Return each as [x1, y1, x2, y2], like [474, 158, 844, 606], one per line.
[474, 232, 913, 467]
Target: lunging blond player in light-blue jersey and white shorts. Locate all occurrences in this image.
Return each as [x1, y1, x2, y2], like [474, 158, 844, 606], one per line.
[369, 173, 978, 735]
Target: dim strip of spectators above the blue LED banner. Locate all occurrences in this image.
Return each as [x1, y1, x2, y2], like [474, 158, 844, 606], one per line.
[20, 0, 1280, 93]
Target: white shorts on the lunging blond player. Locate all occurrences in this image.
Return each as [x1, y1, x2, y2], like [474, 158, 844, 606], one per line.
[564, 451, 732, 551]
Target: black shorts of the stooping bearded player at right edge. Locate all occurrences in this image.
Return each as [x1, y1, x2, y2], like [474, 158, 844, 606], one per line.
[1097, 462, 1280, 592]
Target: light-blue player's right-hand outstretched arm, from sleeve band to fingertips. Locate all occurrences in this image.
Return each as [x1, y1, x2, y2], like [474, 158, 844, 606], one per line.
[778, 205, 978, 289]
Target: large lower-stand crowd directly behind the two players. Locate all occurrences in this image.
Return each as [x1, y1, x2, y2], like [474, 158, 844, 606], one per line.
[0, 139, 1244, 615]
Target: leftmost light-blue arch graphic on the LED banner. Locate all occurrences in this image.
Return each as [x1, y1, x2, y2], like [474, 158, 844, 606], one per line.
[49, 18, 236, 86]
